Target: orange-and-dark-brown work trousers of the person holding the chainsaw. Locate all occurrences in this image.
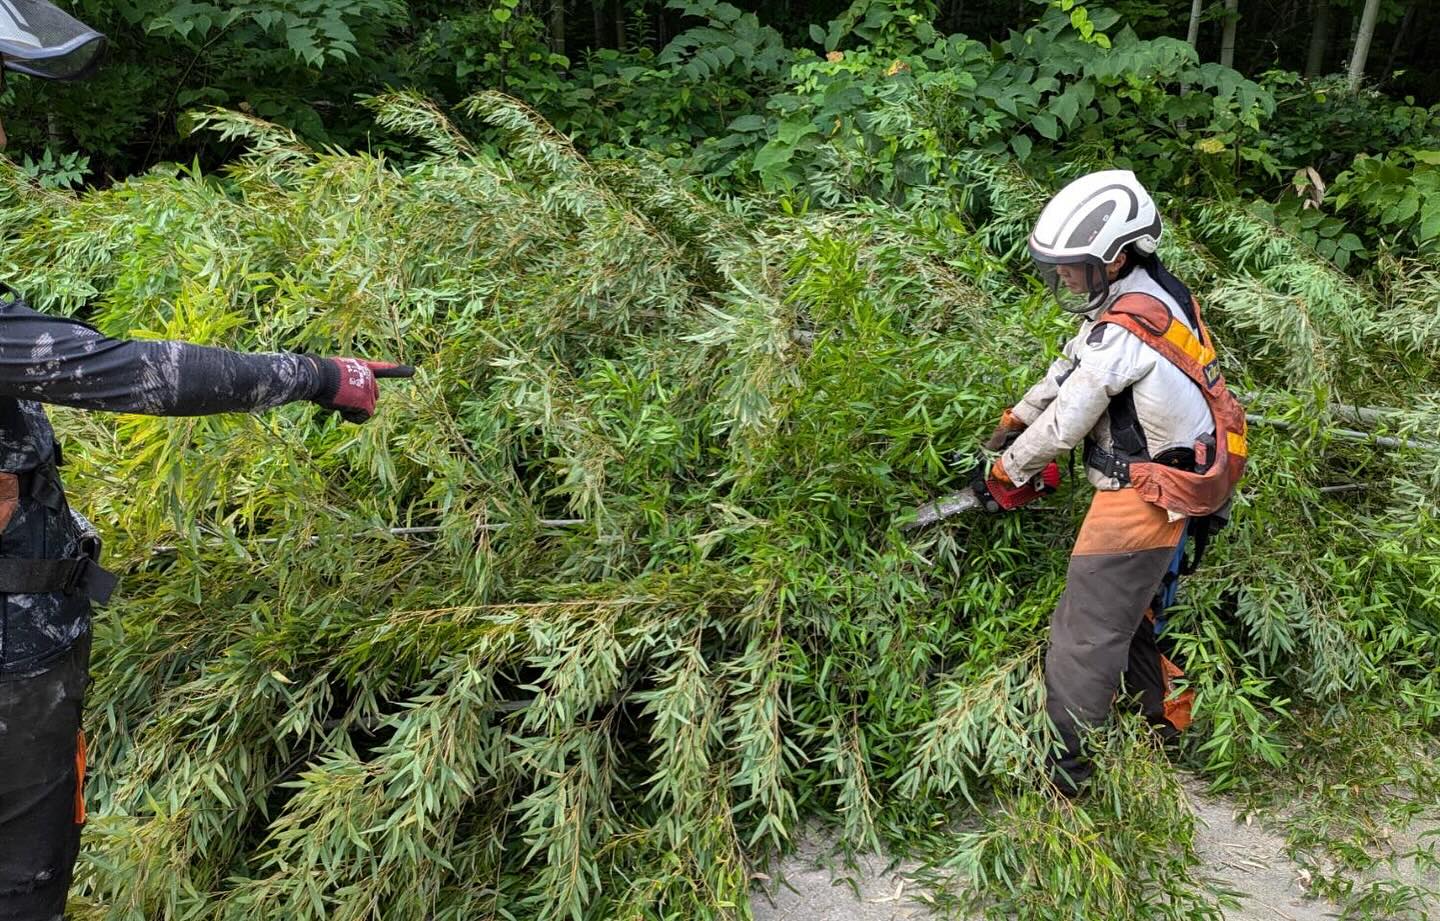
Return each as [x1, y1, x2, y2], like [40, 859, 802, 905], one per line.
[1045, 489, 1185, 791]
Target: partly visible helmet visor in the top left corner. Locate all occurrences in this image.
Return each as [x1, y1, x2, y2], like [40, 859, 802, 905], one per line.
[0, 0, 105, 81]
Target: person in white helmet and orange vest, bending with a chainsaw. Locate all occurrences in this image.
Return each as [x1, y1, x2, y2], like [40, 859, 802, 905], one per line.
[986, 170, 1246, 793]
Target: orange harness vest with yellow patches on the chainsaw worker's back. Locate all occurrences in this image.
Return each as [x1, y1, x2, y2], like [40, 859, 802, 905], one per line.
[1096, 292, 1247, 518]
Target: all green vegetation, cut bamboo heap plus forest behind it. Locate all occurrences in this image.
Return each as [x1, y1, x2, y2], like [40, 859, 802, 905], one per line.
[0, 0, 1440, 921]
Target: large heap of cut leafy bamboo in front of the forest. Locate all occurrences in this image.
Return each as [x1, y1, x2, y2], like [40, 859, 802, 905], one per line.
[0, 95, 1440, 921]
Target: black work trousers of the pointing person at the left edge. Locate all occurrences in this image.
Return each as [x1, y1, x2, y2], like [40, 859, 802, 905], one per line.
[0, 633, 91, 921]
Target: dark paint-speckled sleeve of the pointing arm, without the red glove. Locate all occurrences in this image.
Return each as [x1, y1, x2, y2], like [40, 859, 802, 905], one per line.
[0, 301, 321, 416]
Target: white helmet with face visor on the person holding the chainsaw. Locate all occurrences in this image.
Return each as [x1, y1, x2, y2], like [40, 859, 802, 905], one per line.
[1030, 170, 1161, 314]
